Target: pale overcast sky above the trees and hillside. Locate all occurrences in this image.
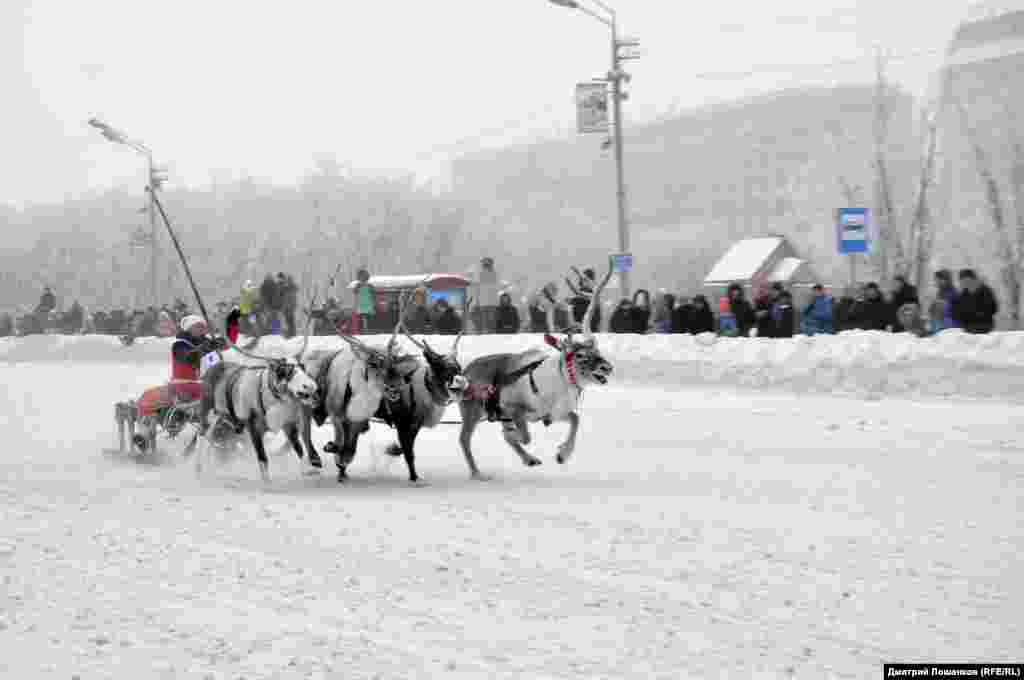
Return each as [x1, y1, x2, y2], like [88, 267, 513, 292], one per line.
[0, 0, 970, 204]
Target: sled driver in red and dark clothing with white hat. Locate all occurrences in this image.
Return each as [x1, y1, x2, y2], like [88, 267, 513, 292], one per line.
[135, 314, 227, 440]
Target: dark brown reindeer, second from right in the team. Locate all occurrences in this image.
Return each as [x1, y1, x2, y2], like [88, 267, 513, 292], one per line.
[377, 288, 468, 484]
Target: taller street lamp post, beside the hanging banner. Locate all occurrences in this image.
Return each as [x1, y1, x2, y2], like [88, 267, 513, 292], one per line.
[548, 0, 637, 297]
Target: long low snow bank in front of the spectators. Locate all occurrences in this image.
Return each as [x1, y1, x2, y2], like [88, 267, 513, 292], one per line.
[0, 331, 1024, 401]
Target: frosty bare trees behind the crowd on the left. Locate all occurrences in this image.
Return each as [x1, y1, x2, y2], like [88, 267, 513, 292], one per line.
[0, 158, 467, 311]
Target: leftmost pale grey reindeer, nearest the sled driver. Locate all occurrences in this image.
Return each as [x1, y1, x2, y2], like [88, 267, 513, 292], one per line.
[189, 324, 323, 482]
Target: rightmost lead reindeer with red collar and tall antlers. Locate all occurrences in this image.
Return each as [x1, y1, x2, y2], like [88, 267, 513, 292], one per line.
[459, 266, 612, 479]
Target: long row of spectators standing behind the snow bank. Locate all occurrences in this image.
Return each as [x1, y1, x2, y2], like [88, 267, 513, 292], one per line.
[0, 257, 998, 338]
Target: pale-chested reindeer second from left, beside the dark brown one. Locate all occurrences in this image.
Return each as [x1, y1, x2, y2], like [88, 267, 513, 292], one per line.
[300, 329, 407, 482]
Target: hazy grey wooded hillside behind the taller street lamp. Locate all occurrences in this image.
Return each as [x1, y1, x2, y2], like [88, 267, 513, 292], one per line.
[452, 86, 916, 291]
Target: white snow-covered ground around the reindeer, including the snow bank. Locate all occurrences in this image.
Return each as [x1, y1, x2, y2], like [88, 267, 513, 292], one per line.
[0, 334, 1024, 680]
